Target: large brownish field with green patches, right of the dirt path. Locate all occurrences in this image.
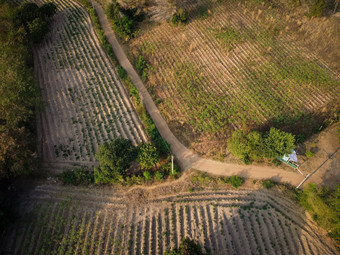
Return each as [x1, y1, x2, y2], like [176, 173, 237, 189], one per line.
[129, 0, 340, 154]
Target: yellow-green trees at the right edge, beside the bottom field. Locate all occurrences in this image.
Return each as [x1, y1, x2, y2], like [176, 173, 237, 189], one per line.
[298, 183, 340, 243]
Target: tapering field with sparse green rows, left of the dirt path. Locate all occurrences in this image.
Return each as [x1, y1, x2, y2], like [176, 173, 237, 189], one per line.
[34, 0, 147, 168]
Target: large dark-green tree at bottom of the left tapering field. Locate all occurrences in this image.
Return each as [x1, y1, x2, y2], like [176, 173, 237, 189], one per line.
[94, 137, 137, 183]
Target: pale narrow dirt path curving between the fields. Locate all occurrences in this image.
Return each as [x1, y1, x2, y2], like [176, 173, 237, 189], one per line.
[93, 1, 304, 186]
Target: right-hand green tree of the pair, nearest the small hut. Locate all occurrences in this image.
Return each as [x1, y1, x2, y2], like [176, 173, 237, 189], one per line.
[263, 128, 295, 158]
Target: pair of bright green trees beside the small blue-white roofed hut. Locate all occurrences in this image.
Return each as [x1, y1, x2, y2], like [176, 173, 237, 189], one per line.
[228, 128, 295, 163]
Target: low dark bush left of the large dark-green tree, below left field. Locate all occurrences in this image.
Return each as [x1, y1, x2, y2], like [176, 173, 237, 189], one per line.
[60, 168, 94, 185]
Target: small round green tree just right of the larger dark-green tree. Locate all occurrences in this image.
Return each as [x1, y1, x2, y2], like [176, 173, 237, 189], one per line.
[137, 143, 159, 169]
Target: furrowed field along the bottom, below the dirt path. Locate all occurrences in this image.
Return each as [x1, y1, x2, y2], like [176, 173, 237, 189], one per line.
[0, 178, 337, 254]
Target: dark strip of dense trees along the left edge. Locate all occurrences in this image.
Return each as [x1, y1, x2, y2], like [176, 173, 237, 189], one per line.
[0, 2, 55, 179]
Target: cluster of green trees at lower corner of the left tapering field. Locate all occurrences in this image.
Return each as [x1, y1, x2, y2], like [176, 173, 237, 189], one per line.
[94, 137, 170, 183]
